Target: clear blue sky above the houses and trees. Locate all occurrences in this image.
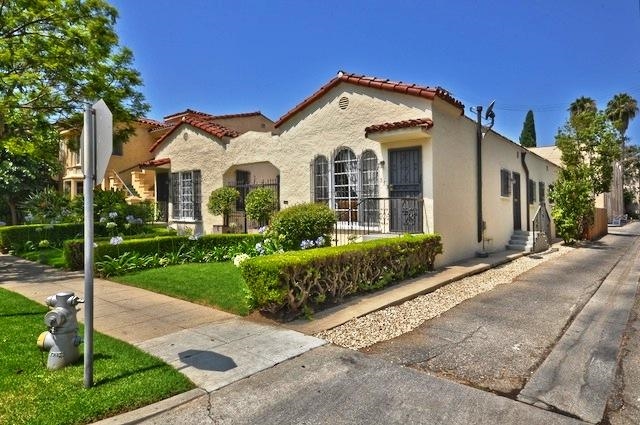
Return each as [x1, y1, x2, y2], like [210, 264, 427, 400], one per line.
[110, 0, 640, 146]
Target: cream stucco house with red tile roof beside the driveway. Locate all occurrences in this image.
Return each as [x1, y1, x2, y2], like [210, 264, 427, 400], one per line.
[145, 72, 559, 265]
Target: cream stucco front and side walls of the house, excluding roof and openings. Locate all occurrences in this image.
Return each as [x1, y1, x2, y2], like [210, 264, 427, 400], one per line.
[156, 80, 557, 266]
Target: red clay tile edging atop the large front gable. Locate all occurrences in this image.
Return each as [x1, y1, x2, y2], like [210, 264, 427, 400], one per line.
[275, 71, 464, 128]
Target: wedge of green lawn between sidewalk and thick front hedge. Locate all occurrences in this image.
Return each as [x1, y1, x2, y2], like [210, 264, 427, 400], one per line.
[109, 262, 251, 316]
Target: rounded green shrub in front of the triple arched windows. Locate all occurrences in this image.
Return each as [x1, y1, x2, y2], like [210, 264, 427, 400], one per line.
[271, 203, 336, 251]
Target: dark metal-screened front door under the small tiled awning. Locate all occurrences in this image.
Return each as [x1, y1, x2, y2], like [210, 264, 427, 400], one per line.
[389, 146, 423, 233]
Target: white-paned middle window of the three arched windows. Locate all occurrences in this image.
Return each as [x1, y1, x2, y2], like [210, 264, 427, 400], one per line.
[333, 148, 358, 222]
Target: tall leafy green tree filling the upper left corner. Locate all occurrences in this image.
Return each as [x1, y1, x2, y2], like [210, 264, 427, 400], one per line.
[0, 0, 149, 224]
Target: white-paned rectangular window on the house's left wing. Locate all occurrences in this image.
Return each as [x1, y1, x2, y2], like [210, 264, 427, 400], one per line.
[171, 170, 202, 220]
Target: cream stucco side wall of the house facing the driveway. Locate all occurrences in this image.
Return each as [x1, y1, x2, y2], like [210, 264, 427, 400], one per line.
[431, 102, 558, 266]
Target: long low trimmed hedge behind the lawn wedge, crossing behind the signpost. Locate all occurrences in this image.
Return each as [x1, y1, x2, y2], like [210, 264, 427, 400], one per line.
[63, 234, 263, 270]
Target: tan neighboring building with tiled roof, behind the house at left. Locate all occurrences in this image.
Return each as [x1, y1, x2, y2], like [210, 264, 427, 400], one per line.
[60, 109, 274, 221]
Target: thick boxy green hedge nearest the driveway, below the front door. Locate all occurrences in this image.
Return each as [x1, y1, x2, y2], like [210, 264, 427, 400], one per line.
[242, 234, 442, 318]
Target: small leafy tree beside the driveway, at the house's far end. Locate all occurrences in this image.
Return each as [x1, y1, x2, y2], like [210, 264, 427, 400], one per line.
[549, 102, 620, 242]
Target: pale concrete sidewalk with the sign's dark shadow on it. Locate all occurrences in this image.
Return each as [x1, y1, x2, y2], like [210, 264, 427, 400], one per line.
[0, 255, 326, 391]
